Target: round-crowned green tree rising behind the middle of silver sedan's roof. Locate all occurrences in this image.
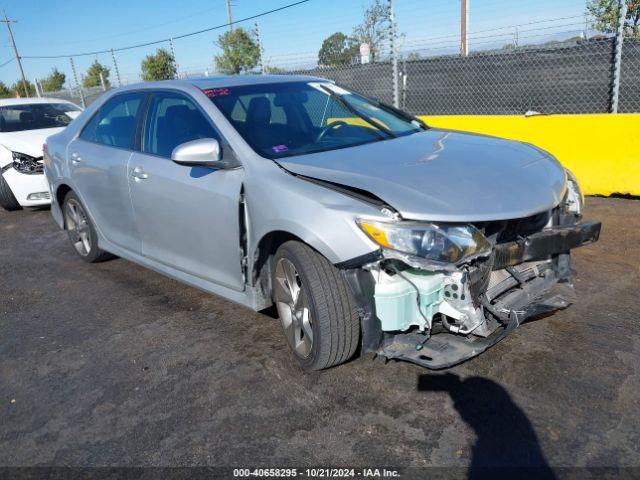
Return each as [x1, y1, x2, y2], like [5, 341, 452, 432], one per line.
[214, 28, 260, 75]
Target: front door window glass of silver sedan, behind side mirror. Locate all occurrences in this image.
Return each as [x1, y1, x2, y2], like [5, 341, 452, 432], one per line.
[142, 93, 220, 158]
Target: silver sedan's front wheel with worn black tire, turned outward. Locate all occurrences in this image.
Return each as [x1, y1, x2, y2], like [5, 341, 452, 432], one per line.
[272, 241, 360, 371]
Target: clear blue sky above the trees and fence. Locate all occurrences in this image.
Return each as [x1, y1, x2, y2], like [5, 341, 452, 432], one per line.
[0, 0, 585, 88]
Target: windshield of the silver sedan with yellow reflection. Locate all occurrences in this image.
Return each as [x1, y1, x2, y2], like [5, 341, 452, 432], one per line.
[204, 82, 426, 159]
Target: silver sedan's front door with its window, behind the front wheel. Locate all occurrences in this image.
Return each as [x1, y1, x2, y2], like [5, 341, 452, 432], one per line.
[129, 91, 244, 291]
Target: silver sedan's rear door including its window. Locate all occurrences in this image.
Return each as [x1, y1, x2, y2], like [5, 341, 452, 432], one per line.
[67, 93, 145, 254]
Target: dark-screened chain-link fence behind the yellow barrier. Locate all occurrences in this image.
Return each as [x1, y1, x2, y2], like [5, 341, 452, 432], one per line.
[278, 37, 640, 115]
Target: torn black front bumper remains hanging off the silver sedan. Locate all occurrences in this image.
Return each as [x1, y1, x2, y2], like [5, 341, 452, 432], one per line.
[343, 222, 601, 369]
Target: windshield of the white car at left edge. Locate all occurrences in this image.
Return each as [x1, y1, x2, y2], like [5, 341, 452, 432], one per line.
[0, 103, 79, 132]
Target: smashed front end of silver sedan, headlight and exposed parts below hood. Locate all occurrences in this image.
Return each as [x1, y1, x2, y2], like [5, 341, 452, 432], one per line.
[343, 198, 600, 369]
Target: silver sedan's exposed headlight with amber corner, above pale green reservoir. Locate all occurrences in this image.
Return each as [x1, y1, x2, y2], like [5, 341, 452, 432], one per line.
[357, 219, 492, 264]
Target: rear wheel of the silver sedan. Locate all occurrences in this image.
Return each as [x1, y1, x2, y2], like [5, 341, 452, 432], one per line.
[62, 192, 112, 263]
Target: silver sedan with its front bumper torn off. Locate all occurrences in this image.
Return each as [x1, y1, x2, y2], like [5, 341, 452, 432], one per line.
[45, 75, 600, 370]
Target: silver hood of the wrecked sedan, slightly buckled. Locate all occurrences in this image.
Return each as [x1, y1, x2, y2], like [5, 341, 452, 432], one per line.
[277, 129, 566, 222]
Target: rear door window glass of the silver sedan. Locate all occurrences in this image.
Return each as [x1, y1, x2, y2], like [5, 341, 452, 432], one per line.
[80, 93, 143, 149]
